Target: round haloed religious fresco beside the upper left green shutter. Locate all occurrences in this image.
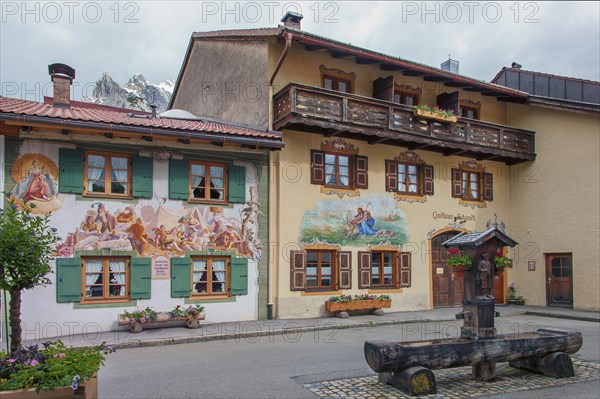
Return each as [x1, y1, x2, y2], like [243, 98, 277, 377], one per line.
[10, 154, 64, 214]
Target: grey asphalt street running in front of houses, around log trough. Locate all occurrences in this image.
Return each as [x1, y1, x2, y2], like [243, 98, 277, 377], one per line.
[99, 314, 600, 398]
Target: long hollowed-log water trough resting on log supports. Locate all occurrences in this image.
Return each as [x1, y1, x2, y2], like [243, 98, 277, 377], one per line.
[364, 329, 583, 395]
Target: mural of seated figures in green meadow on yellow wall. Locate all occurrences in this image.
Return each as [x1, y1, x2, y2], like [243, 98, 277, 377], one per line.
[301, 194, 408, 246]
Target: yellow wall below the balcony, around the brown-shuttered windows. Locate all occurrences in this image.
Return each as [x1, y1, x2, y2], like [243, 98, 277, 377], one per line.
[271, 130, 510, 317]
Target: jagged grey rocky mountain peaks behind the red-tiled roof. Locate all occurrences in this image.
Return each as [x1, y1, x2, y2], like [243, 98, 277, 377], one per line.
[83, 72, 175, 113]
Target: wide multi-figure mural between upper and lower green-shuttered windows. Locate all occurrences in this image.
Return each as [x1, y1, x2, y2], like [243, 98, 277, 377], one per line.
[56, 188, 262, 261]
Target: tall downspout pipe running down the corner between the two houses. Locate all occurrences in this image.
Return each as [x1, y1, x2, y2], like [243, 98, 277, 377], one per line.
[267, 32, 294, 320]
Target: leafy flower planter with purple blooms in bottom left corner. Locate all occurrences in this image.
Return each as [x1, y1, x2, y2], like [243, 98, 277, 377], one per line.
[0, 341, 113, 399]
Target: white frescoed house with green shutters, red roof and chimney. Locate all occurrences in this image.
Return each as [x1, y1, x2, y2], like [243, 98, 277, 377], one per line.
[0, 64, 283, 338]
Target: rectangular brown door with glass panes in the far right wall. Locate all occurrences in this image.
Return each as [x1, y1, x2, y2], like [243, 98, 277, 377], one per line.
[546, 254, 573, 308]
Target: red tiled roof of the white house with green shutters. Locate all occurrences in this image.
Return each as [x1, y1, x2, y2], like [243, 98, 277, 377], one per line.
[0, 97, 284, 149]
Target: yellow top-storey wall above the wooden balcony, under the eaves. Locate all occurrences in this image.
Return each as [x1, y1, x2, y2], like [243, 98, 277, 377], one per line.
[269, 40, 506, 124]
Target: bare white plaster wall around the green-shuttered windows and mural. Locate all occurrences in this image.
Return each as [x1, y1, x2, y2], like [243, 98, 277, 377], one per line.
[9, 136, 268, 340]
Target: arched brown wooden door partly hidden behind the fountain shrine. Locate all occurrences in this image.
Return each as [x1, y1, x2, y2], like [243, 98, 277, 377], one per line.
[431, 231, 464, 307]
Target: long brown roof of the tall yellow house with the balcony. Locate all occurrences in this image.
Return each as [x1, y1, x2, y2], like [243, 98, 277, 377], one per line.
[169, 25, 528, 108]
